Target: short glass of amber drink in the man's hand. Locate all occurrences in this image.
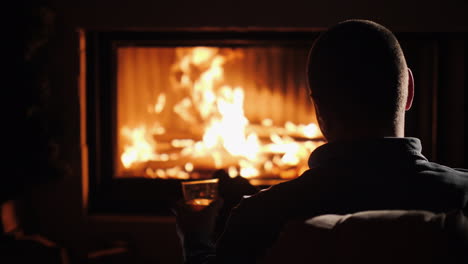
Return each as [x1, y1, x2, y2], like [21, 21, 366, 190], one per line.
[182, 179, 218, 211]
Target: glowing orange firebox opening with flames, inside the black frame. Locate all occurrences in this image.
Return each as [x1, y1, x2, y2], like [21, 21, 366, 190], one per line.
[114, 45, 324, 184]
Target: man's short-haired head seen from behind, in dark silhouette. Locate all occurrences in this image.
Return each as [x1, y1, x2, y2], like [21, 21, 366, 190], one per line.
[308, 20, 413, 141]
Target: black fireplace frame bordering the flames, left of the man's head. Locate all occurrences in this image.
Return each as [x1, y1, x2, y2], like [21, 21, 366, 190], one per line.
[81, 28, 320, 216]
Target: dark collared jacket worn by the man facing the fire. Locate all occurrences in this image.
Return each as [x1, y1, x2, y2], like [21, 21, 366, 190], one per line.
[191, 138, 468, 263]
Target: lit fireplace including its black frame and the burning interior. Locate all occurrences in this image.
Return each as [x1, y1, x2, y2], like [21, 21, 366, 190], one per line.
[82, 29, 324, 213]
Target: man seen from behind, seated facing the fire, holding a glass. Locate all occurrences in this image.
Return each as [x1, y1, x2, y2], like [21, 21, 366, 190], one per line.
[178, 20, 468, 263]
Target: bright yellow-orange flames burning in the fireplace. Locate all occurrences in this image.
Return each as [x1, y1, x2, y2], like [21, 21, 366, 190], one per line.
[120, 47, 323, 179]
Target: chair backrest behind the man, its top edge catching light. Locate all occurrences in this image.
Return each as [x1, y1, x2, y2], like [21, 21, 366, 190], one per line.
[262, 211, 468, 264]
